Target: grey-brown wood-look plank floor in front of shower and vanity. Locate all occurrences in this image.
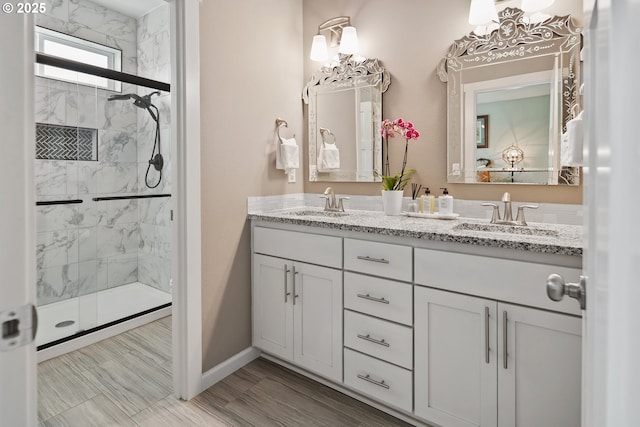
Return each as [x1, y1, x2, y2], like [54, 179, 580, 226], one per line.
[38, 317, 409, 427]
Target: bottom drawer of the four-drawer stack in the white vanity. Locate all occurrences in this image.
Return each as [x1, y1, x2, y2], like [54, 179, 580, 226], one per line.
[344, 348, 413, 412]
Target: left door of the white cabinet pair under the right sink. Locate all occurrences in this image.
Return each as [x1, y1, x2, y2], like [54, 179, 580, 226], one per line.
[414, 286, 498, 427]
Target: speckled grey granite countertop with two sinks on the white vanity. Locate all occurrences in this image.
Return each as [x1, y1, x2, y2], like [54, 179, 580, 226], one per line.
[248, 207, 583, 256]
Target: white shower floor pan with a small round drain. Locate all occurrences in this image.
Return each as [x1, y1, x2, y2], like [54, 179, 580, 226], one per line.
[36, 282, 171, 346]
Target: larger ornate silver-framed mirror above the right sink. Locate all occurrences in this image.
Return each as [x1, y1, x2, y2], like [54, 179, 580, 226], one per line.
[438, 8, 582, 185]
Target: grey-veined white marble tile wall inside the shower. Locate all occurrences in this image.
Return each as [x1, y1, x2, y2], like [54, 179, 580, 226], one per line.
[35, 0, 170, 305]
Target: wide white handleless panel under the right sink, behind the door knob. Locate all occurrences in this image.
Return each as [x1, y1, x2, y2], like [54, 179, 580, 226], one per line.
[415, 248, 581, 316]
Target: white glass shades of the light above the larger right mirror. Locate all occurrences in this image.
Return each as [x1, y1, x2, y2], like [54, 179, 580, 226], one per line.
[469, 0, 555, 36]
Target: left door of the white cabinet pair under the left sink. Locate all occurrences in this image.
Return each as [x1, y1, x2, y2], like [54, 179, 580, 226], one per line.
[252, 254, 293, 361]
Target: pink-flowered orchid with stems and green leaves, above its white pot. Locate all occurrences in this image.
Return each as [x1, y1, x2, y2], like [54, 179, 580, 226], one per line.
[380, 118, 420, 191]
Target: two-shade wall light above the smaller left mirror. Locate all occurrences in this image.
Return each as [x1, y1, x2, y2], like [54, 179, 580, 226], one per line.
[309, 16, 358, 61]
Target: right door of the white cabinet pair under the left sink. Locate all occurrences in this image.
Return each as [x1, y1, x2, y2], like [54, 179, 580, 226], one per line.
[291, 263, 342, 382]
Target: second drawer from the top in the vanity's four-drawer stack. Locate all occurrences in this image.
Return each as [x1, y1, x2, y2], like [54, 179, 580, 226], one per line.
[344, 272, 413, 326]
